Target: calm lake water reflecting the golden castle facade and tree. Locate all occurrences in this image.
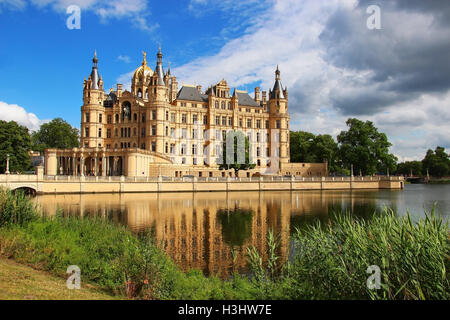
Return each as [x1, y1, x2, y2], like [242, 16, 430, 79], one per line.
[35, 184, 450, 277]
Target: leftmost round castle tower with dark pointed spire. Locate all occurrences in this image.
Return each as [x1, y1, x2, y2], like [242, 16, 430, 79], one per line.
[81, 51, 106, 148]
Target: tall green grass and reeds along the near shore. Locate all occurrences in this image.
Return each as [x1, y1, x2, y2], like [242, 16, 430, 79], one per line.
[0, 191, 450, 299]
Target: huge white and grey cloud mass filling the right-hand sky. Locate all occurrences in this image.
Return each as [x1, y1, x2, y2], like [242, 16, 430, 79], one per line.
[174, 0, 450, 159]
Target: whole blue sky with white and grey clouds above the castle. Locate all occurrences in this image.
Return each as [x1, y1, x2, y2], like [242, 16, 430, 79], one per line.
[0, 0, 450, 161]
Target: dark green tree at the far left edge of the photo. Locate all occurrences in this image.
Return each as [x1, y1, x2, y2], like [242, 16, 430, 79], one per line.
[0, 120, 31, 173]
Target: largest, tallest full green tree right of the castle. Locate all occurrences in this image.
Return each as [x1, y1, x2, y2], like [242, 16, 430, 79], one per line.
[337, 118, 397, 175]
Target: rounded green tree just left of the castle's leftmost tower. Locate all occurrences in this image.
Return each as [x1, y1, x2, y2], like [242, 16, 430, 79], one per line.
[31, 118, 80, 152]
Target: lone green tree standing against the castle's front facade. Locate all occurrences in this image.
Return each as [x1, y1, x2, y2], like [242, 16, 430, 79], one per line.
[219, 131, 256, 176]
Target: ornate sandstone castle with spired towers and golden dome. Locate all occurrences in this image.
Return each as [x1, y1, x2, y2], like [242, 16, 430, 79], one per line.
[45, 48, 327, 177]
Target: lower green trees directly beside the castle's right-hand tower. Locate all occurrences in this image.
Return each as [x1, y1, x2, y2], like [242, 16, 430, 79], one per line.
[290, 131, 340, 172]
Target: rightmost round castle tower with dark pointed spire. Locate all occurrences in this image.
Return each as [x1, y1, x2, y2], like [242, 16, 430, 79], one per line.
[269, 66, 290, 164]
